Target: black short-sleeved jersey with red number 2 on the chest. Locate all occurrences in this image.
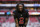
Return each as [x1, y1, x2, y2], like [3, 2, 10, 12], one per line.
[13, 10, 29, 25]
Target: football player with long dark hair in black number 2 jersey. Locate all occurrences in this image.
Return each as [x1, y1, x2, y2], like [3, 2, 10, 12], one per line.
[13, 3, 29, 27]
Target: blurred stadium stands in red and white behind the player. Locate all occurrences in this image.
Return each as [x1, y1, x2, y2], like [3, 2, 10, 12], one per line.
[0, 0, 40, 27]
